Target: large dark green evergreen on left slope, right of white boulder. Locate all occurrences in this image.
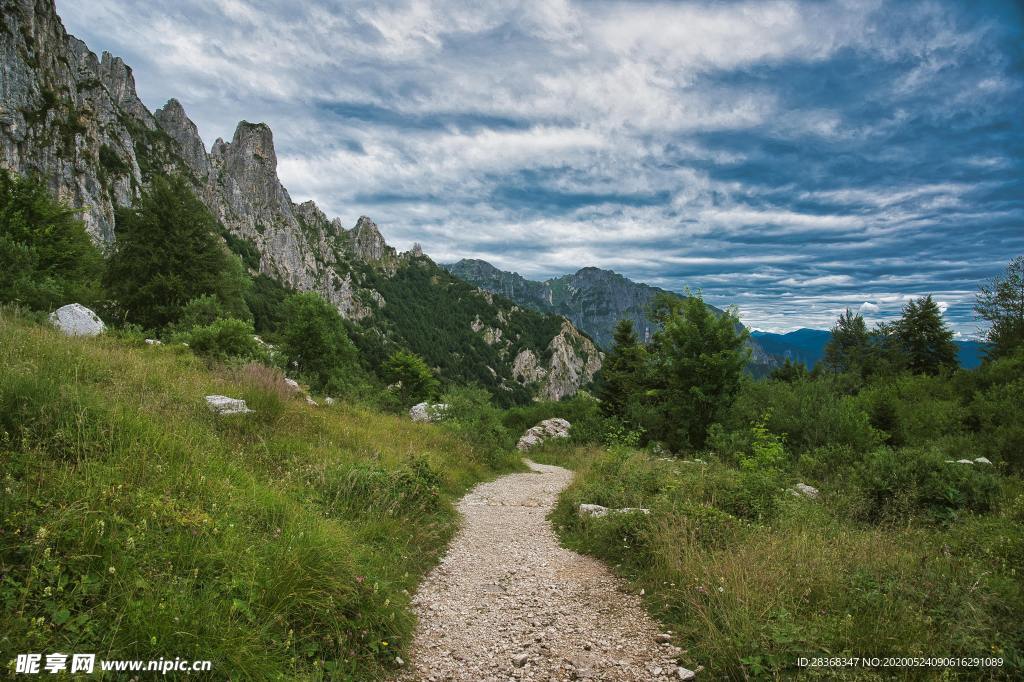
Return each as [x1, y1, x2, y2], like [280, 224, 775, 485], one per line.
[105, 176, 250, 329]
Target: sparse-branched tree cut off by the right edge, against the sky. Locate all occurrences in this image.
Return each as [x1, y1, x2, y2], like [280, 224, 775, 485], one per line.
[974, 256, 1024, 358]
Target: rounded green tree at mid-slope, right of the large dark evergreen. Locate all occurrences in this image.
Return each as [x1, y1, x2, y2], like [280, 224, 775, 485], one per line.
[279, 292, 367, 395]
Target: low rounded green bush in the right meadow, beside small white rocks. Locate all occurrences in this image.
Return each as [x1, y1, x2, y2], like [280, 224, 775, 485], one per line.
[854, 447, 998, 520]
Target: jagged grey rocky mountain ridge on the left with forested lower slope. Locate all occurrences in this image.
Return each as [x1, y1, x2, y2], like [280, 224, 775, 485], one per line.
[0, 0, 601, 401]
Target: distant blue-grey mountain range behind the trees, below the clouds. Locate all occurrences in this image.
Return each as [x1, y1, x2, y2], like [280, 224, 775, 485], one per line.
[442, 259, 777, 366]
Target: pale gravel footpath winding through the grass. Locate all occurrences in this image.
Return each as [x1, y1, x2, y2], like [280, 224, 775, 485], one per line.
[402, 463, 688, 682]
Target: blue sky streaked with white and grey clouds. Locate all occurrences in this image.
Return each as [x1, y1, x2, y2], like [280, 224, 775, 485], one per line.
[57, 0, 1024, 337]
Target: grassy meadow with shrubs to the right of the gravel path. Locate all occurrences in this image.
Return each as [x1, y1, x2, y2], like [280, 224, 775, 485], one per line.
[530, 447, 1024, 680]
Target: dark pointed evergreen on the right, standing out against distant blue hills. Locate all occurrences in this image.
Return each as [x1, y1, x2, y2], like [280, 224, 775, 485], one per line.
[894, 296, 956, 375]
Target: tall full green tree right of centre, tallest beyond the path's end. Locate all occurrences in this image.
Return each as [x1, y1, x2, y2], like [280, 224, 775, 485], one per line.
[645, 288, 750, 450]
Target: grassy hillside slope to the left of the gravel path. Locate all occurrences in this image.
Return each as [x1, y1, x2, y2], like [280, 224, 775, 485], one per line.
[0, 310, 519, 680]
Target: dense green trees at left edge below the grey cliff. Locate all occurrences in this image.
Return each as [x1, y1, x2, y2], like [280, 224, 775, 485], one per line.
[0, 170, 103, 311]
